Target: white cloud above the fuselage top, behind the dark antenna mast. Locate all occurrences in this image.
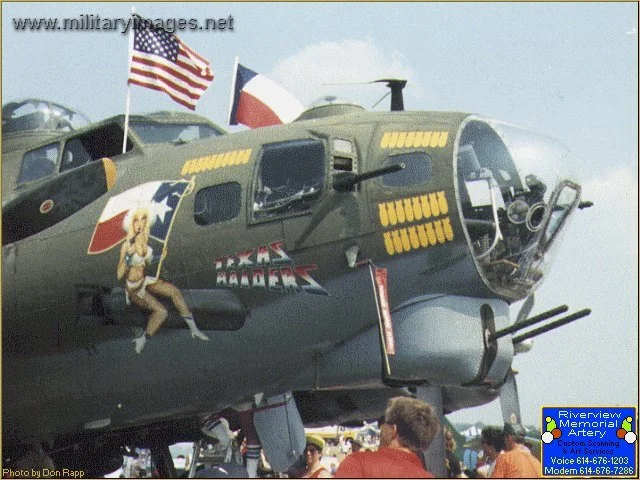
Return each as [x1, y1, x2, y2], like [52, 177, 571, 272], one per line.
[269, 40, 416, 109]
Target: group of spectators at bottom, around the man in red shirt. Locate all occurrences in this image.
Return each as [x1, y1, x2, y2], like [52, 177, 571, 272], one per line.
[289, 397, 542, 478]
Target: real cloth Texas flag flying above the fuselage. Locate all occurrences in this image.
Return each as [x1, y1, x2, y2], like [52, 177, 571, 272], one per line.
[229, 63, 304, 128]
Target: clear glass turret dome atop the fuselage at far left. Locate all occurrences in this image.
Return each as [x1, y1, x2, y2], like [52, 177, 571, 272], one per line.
[2, 99, 90, 133]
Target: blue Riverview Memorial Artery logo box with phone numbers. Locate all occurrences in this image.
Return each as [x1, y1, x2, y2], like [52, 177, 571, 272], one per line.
[541, 407, 638, 477]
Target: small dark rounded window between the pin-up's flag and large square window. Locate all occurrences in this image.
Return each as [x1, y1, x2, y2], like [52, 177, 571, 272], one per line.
[193, 182, 242, 227]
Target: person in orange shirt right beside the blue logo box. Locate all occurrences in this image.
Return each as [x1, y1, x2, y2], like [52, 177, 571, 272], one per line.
[491, 423, 542, 478]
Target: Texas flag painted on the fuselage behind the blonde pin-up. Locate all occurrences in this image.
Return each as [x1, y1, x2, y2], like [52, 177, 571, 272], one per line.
[87, 180, 190, 254]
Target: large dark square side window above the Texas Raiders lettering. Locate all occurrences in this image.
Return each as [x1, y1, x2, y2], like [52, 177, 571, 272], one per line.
[253, 140, 326, 218]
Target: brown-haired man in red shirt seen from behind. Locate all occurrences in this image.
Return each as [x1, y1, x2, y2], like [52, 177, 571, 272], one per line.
[335, 397, 440, 478]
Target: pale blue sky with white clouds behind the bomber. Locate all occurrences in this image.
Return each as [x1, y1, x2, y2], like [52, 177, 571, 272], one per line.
[2, 2, 638, 432]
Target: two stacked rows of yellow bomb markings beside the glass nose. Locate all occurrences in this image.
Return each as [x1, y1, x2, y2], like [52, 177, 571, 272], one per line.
[378, 191, 453, 255]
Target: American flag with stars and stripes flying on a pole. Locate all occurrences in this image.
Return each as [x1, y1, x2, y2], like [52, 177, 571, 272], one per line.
[129, 20, 213, 110]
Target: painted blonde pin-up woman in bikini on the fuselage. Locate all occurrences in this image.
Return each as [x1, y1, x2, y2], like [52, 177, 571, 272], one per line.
[117, 207, 209, 353]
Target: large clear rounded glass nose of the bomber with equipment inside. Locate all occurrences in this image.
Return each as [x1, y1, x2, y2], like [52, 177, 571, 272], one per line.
[457, 117, 580, 300]
